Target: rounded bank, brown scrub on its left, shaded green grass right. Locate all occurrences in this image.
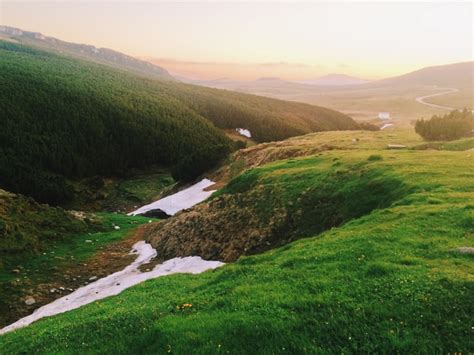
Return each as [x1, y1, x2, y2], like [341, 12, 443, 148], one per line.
[144, 156, 410, 262]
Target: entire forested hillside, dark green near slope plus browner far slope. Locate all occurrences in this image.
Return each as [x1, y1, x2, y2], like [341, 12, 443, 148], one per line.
[0, 41, 357, 204]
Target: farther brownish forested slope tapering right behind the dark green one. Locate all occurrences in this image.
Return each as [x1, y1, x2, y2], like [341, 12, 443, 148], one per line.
[160, 83, 359, 142]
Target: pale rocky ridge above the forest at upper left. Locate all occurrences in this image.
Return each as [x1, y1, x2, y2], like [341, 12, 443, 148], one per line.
[0, 26, 175, 80]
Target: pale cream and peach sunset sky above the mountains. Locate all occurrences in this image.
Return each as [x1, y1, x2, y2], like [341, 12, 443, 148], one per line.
[0, 0, 473, 79]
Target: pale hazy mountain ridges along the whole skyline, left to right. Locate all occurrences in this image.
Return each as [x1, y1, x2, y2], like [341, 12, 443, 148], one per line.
[5, 26, 466, 91]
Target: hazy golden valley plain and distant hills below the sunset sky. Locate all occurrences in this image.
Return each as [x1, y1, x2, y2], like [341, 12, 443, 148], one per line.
[174, 62, 474, 122]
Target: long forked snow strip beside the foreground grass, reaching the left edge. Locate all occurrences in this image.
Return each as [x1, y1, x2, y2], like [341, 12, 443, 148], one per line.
[0, 241, 224, 334]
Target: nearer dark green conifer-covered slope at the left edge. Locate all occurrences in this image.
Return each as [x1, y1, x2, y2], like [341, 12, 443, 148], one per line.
[0, 42, 230, 203]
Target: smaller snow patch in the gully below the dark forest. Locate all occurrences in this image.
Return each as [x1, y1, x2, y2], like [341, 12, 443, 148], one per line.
[128, 179, 215, 216]
